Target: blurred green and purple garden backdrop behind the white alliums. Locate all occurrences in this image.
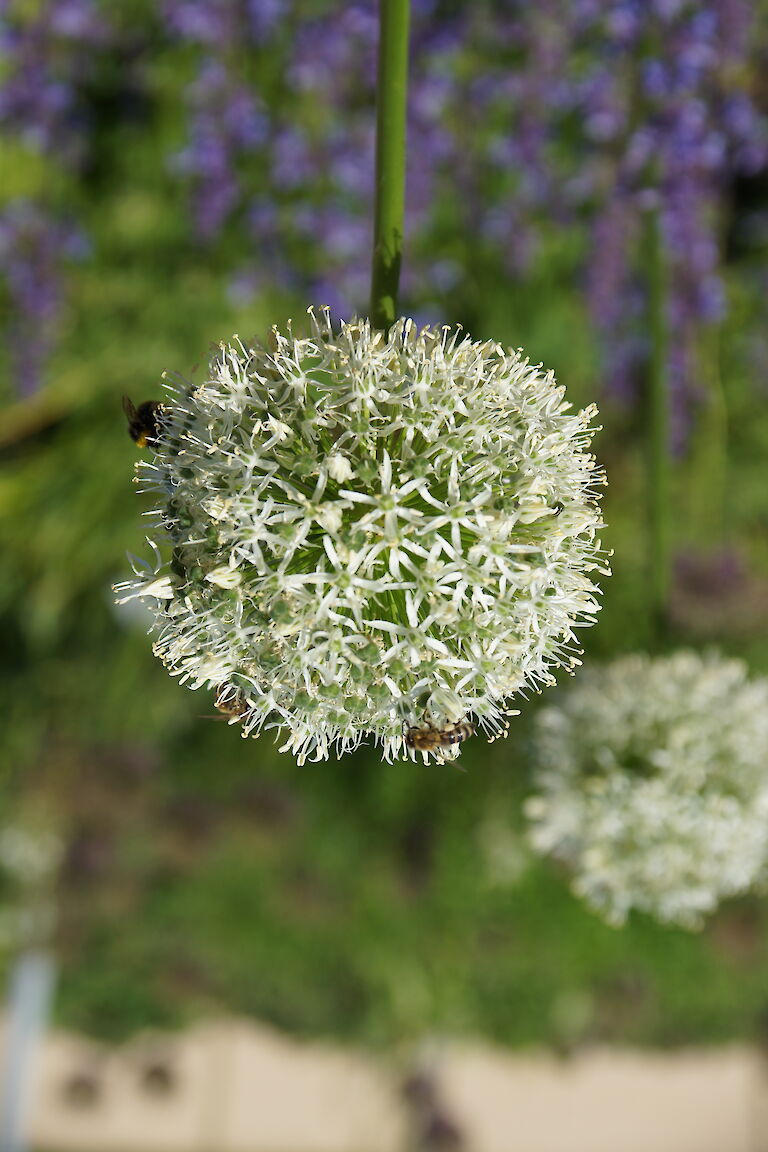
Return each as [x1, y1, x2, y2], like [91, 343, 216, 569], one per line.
[0, 0, 768, 1069]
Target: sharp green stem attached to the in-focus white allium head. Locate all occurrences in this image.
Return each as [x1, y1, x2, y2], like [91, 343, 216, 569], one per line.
[371, 0, 410, 331]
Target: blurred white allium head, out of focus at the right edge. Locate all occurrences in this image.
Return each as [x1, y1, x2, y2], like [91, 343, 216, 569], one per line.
[526, 652, 768, 926]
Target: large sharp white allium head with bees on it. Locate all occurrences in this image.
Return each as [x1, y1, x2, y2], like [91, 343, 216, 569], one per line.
[119, 310, 604, 760]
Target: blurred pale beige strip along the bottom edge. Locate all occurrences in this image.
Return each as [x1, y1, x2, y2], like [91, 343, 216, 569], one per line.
[1, 1022, 768, 1152]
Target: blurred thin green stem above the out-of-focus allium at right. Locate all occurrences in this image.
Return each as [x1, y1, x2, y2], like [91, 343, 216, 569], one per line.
[646, 209, 671, 639]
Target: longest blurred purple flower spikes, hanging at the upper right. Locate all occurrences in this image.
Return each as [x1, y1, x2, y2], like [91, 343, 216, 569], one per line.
[571, 0, 768, 447]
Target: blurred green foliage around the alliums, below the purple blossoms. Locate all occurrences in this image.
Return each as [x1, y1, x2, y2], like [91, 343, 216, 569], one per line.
[0, 18, 768, 1047]
